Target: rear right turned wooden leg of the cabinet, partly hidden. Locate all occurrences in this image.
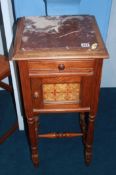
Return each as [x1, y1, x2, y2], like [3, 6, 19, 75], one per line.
[80, 113, 87, 144]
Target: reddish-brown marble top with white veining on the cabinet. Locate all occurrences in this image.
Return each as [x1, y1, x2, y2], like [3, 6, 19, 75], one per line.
[20, 15, 99, 51]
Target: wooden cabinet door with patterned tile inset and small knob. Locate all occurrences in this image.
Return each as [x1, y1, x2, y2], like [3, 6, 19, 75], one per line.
[30, 76, 92, 111]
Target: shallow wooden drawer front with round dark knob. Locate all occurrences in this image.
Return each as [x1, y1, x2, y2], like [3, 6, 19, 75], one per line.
[28, 60, 94, 75]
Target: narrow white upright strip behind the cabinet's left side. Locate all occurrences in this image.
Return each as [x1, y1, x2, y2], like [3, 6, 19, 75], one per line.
[0, 0, 24, 130]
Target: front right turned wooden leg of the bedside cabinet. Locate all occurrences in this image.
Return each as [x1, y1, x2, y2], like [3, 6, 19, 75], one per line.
[85, 114, 95, 165]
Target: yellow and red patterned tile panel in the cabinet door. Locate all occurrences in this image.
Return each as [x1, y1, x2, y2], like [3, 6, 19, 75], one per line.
[43, 83, 80, 103]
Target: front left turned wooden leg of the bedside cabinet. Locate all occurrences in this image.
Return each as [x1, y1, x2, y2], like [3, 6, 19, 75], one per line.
[27, 117, 39, 167]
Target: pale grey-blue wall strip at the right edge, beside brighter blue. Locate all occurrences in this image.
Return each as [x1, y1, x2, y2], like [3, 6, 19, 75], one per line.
[102, 0, 116, 87]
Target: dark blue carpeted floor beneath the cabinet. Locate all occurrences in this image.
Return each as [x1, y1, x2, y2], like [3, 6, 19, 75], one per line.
[0, 88, 116, 175]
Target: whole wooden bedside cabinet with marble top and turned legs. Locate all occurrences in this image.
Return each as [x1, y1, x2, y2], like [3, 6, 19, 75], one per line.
[13, 15, 108, 166]
